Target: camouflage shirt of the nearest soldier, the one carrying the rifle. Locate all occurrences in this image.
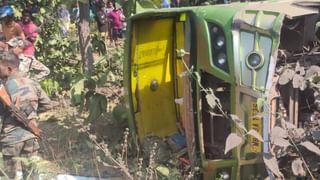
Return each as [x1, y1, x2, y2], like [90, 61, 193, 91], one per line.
[0, 75, 51, 145]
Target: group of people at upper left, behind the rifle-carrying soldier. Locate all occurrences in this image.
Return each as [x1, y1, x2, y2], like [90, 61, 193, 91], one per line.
[0, 4, 50, 81]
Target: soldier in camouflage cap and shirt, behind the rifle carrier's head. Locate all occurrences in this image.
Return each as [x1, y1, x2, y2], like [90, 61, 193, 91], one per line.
[7, 38, 50, 82]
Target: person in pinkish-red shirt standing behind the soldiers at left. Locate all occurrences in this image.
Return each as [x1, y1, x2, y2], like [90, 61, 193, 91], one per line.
[20, 10, 39, 56]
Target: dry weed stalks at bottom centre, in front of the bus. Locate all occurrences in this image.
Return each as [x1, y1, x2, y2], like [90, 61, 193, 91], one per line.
[76, 121, 199, 180]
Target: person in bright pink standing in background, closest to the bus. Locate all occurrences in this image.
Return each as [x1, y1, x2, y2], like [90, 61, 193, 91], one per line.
[108, 8, 123, 46]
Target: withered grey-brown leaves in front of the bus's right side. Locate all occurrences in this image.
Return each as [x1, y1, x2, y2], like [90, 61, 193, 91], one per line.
[227, 54, 320, 179]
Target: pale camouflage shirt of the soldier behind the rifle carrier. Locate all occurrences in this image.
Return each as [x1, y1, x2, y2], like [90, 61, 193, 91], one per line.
[19, 54, 50, 82]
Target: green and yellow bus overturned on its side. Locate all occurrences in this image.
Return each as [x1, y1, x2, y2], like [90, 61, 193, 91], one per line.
[124, 1, 320, 179]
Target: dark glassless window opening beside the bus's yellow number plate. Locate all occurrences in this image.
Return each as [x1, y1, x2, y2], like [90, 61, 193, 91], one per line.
[201, 73, 231, 159]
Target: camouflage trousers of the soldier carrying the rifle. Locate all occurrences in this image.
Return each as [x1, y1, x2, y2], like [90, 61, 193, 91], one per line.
[2, 139, 39, 180]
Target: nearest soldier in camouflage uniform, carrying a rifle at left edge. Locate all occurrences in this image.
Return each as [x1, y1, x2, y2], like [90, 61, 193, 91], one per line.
[0, 52, 52, 180]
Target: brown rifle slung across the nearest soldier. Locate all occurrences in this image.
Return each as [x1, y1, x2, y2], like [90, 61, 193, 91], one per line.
[0, 83, 42, 139]
